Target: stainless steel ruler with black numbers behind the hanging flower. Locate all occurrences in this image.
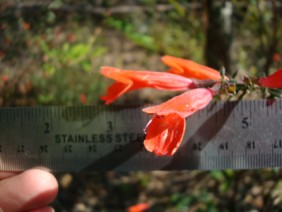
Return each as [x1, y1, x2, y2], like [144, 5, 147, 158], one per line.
[0, 100, 282, 171]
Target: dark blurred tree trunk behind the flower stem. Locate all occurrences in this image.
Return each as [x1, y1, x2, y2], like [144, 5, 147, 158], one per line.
[204, 0, 232, 73]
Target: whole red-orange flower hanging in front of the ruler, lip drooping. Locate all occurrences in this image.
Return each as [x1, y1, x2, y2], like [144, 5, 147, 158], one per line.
[143, 88, 214, 156]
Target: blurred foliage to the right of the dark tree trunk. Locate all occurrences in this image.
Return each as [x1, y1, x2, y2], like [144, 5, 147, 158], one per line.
[234, 1, 282, 76]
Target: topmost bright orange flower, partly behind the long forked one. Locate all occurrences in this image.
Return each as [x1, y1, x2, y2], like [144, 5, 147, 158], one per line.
[162, 55, 224, 81]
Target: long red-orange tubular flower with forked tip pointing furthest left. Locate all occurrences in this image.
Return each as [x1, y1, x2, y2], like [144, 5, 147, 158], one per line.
[101, 67, 195, 104]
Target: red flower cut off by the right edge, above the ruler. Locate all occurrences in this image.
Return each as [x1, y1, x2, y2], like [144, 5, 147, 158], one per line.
[259, 68, 282, 88]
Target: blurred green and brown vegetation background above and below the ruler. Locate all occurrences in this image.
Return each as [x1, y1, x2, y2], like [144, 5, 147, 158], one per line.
[0, 0, 282, 211]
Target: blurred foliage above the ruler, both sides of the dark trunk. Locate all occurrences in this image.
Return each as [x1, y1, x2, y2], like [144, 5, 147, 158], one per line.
[0, 0, 282, 105]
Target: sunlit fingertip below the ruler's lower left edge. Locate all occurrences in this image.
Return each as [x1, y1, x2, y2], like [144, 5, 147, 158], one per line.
[0, 169, 58, 211]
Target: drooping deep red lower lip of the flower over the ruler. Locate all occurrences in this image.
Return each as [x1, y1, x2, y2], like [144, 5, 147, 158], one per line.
[144, 113, 186, 156]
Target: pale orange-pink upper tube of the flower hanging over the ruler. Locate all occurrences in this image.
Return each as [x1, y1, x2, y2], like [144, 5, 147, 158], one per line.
[143, 88, 213, 118]
